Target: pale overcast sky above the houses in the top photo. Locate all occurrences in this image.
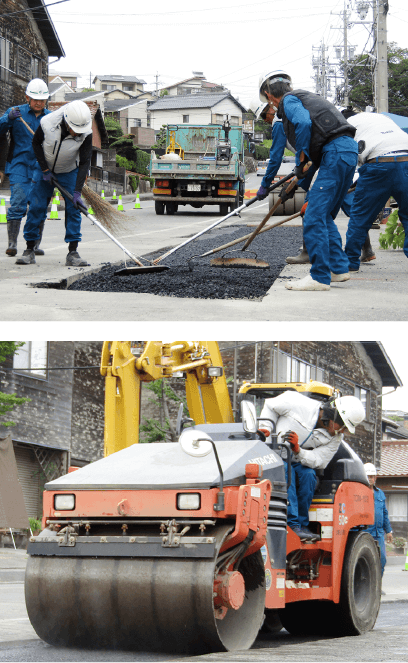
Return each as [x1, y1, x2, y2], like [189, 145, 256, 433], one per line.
[46, 0, 408, 107]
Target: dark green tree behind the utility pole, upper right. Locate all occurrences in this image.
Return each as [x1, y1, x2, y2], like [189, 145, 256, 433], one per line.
[349, 42, 408, 117]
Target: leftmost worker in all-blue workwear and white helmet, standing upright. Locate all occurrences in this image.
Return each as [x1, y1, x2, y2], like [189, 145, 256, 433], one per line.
[0, 78, 50, 256]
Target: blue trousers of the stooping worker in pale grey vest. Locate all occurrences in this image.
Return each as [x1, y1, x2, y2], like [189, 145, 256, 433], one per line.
[24, 166, 82, 243]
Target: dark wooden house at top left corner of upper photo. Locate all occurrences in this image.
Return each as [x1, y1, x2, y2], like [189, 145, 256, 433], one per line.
[0, 0, 65, 115]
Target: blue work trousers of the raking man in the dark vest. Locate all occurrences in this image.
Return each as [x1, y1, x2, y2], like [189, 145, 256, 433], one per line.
[303, 136, 358, 285]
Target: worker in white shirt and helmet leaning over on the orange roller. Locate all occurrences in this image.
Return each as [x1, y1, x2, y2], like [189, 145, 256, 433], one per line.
[259, 391, 365, 541]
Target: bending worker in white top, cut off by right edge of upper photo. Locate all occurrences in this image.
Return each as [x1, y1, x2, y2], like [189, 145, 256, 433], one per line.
[345, 113, 408, 272]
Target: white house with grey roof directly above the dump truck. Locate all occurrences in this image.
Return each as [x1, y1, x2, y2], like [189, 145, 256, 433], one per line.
[148, 92, 245, 131]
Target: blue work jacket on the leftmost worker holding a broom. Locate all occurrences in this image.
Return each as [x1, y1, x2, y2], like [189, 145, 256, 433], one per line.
[0, 104, 51, 184]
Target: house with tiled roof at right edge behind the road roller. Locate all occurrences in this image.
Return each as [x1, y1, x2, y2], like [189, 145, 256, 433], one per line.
[376, 440, 408, 540]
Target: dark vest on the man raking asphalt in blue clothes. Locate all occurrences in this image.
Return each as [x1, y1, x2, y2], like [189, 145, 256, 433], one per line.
[277, 90, 356, 166]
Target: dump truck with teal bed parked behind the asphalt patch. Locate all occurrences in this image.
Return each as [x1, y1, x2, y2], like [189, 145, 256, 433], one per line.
[150, 120, 245, 216]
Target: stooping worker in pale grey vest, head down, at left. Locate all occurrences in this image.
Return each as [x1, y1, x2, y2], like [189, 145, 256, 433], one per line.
[16, 100, 92, 267]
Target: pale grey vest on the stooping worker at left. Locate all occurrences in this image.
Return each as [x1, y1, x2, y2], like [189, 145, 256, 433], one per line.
[41, 106, 92, 173]
